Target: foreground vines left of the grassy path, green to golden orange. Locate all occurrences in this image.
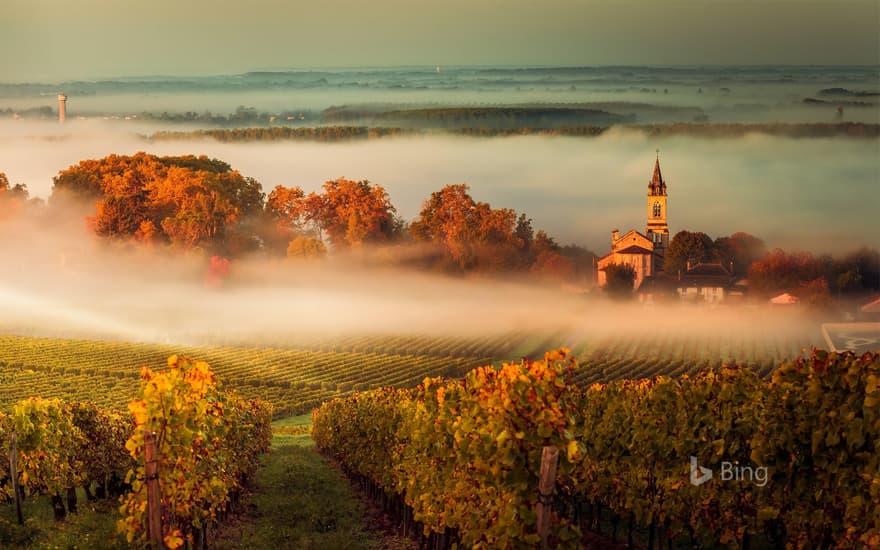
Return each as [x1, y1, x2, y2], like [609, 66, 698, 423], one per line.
[0, 355, 272, 550]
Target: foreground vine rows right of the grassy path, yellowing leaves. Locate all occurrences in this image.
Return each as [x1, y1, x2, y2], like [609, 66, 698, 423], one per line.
[313, 350, 880, 549]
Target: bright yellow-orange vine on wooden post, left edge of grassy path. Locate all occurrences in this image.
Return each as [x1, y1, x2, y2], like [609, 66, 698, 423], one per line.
[118, 355, 272, 548]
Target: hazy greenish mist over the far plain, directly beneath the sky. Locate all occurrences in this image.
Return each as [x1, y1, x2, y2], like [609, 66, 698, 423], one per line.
[0, 65, 880, 124]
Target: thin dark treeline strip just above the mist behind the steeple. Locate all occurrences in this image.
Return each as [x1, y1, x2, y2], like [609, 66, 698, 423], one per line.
[147, 122, 880, 142]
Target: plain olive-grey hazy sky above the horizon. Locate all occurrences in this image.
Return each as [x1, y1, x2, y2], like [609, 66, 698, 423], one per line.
[0, 0, 880, 82]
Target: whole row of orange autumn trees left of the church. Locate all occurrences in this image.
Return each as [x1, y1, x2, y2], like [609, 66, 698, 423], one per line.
[43, 153, 594, 286]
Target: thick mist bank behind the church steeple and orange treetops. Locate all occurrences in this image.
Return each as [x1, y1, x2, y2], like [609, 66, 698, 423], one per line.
[0, 121, 880, 254]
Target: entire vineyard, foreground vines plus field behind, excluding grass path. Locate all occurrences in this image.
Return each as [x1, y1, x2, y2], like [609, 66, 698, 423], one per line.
[0, 327, 868, 548]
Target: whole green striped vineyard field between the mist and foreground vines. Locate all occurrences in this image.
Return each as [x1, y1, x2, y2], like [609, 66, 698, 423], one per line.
[0, 328, 821, 417]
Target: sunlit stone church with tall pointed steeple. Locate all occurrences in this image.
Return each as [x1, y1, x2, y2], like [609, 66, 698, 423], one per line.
[597, 151, 669, 288]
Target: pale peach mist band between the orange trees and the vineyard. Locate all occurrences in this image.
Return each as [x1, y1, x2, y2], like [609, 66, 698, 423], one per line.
[0, 209, 817, 352]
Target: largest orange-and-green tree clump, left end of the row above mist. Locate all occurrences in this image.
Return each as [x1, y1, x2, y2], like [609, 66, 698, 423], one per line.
[52, 153, 264, 249]
